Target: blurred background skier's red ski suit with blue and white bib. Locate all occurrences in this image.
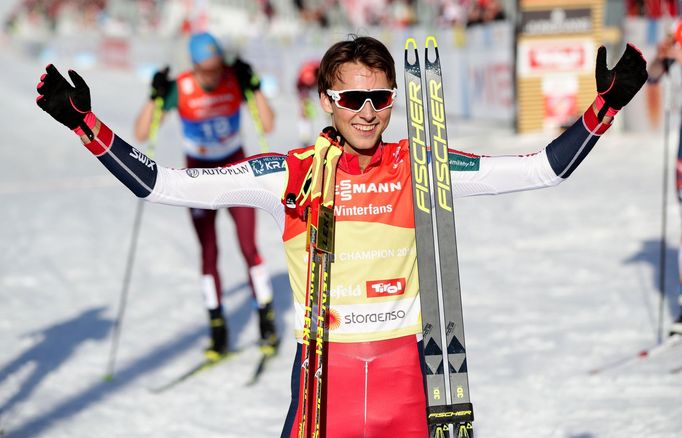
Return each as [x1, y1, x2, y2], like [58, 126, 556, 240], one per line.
[163, 66, 272, 310]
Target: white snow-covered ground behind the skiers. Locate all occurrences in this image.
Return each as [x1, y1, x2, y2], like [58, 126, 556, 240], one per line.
[0, 37, 682, 438]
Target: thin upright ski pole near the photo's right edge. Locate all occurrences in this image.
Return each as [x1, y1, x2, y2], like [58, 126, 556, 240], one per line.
[657, 64, 670, 343]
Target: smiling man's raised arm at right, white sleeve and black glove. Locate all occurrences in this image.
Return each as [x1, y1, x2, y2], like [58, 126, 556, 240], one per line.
[450, 44, 647, 197]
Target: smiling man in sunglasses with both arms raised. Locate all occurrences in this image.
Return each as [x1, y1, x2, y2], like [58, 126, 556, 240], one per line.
[37, 37, 647, 438]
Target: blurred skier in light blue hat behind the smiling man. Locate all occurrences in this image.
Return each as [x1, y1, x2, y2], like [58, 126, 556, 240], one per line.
[135, 32, 279, 359]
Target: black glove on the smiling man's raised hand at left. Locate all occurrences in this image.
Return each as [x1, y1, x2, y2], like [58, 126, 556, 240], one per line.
[36, 64, 96, 140]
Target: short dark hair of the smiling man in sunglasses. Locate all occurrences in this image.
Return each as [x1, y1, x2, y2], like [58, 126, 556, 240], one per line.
[317, 35, 398, 93]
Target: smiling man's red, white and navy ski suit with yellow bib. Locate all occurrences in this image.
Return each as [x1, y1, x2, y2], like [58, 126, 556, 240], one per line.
[79, 103, 609, 438]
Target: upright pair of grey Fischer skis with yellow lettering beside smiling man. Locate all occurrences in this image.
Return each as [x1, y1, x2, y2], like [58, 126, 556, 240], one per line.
[405, 36, 474, 438]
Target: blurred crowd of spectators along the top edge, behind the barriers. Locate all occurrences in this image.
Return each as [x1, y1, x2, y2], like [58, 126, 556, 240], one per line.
[5, 0, 505, 36]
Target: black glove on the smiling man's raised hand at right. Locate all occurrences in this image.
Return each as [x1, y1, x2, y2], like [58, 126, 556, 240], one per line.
[595, 43, 648, 120]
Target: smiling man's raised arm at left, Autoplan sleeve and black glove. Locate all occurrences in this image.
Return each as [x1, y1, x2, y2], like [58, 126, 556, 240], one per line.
[37, 65, 285, 226]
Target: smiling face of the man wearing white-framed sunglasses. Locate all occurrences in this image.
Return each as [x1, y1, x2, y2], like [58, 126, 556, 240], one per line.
[320, 62, 392, 169]
